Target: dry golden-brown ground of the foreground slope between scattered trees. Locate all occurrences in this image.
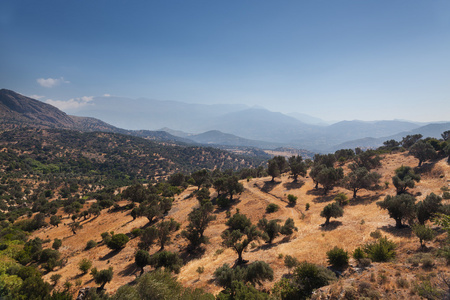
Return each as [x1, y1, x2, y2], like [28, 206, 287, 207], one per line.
[33, 153, 450, 299]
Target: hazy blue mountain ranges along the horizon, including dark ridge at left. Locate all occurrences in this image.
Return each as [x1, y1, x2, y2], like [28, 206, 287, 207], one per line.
[0, 89, 450, 152]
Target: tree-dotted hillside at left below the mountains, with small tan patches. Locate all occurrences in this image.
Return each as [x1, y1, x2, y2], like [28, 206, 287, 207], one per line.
[0, 128, 263, 180]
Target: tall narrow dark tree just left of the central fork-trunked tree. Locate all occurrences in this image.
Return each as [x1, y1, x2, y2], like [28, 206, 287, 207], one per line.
[181, 201, 216, 249]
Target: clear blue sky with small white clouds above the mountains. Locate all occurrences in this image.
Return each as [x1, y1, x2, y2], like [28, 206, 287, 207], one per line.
[0, 0, 450, 121]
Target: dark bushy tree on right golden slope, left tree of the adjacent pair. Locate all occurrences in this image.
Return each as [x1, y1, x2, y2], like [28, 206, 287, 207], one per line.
[377, 194, 416, 228]
